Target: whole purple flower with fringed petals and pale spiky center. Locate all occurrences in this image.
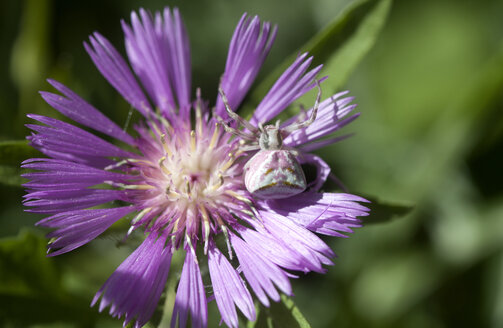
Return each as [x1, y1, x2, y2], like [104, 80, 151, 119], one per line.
[23, 8, 368, 327]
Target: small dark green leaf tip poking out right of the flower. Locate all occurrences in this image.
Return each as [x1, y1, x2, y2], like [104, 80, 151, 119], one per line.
[363, 196, 414, 224]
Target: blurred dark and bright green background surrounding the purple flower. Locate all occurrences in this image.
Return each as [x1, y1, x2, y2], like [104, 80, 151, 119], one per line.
[0, 0, 503, 328]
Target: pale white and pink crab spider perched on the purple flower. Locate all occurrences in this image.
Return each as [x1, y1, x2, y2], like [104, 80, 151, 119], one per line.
[218, 81, 321, 199]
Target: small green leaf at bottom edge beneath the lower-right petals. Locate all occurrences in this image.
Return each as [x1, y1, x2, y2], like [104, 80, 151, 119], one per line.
[251, 295, 311, 328]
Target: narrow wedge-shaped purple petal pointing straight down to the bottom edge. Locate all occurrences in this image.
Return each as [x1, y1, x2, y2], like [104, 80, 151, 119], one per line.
[171, 250, 208, 328]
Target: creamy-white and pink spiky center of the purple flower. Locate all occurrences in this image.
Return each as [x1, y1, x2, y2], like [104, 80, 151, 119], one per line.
[125, 117, 251, 251]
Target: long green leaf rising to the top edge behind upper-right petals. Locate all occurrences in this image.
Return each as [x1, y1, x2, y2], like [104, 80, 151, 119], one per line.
[243, 0, 391, 117]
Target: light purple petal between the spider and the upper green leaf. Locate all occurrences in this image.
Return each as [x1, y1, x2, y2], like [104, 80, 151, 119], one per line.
[250, 53, 322, 125]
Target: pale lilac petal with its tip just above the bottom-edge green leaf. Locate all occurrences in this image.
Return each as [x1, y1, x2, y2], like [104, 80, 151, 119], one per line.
[230, 234, 292, 306]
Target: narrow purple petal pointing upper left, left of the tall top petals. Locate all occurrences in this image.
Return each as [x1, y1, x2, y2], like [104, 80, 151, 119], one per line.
[84, 32, 152, 117]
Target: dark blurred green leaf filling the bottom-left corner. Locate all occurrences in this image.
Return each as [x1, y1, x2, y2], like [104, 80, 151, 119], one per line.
[0, 231, 96, 327]
